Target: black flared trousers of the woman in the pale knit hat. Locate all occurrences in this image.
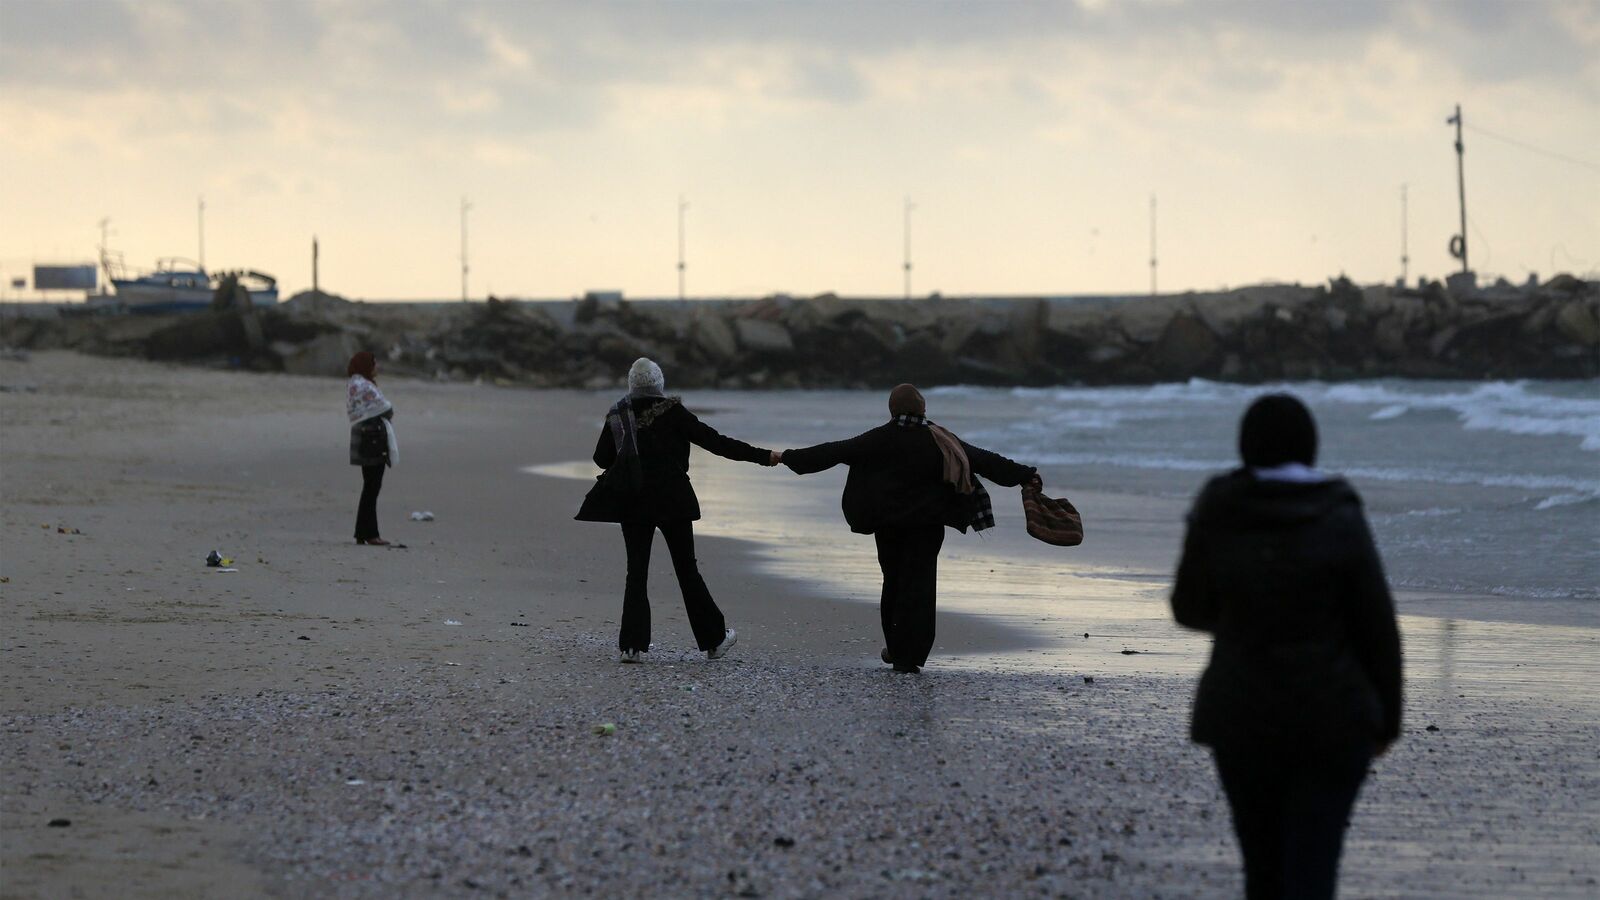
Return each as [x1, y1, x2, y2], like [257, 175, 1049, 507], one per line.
[616, 519, 728, 650]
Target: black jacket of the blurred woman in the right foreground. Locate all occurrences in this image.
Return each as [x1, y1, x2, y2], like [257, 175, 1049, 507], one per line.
[1173, 469, 1400, 753]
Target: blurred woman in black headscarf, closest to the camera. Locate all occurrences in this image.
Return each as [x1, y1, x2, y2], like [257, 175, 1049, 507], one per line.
[1173, 394, 1400, 900]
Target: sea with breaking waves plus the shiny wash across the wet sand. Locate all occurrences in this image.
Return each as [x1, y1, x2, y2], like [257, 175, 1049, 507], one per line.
[539, 380, 1600, 652]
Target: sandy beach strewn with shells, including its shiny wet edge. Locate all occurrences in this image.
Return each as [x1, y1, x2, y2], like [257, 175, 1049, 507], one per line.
[0, 352, 1600, 898]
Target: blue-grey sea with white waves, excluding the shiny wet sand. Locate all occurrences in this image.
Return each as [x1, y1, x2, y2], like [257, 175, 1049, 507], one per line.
[691, 380, 1600, 602]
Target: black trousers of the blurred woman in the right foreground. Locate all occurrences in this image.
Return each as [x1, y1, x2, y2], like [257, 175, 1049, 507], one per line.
[1214, 746, 1373, 900]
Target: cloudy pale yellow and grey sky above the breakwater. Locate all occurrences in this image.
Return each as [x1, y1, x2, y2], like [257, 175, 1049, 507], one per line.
[0, 0, 1600, 298]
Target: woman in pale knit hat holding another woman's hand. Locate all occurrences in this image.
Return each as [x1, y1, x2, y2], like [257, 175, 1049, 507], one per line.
[576, 357, 778, 663]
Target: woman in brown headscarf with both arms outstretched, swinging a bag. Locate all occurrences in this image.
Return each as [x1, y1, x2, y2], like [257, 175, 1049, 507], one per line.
[779, 384, 1038, 673]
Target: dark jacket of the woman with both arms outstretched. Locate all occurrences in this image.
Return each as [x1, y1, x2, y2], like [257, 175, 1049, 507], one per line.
[784, 421, 1034, 535]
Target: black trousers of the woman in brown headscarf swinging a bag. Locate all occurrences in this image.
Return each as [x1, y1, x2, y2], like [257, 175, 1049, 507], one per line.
[872, 525, 944, 666]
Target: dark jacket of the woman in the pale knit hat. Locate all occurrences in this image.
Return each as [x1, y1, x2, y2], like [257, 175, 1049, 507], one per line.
[576, 397, 771, 522]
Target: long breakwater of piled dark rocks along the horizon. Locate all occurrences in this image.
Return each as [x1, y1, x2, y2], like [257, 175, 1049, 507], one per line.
[0, 275, 1600, 388]
